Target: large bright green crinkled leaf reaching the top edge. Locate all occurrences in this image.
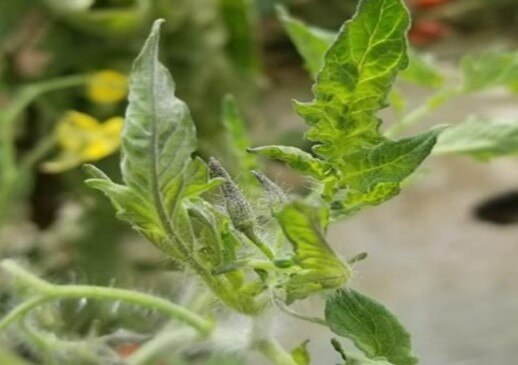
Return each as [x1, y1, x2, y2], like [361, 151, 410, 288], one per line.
[280, 0, 439, 216]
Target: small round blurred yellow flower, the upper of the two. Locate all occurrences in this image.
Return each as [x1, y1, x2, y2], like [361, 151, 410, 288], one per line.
[86, 70, 128, 104]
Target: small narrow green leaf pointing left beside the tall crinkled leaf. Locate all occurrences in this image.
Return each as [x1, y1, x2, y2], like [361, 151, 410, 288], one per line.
[248, 146, 330, 179]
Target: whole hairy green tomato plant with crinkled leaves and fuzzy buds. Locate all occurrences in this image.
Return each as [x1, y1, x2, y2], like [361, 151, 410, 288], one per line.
[0, 0, 518, 365]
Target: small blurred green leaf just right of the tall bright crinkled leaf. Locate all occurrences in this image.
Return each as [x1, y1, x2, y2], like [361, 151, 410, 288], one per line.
[401, 49, 444, 88]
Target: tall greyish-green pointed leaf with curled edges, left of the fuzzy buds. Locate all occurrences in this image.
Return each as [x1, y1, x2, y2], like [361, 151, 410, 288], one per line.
[87, 20, 216, 260]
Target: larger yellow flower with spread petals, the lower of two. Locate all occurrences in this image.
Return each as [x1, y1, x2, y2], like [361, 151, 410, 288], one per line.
[42, 111, 124, 173]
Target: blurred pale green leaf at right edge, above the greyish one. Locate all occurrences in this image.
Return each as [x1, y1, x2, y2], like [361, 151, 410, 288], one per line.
[461, 51, 518, 92]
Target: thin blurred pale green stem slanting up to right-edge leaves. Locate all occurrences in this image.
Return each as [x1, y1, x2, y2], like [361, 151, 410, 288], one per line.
[385, 89, 461, 137]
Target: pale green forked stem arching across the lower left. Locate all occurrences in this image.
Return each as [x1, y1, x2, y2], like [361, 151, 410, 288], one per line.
[0, 260, 213, 335]
